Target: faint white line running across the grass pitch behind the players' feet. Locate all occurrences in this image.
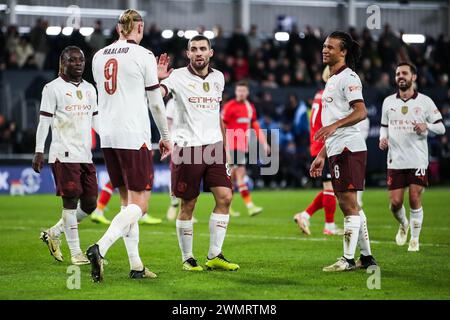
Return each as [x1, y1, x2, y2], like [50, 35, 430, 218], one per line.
[0, 226, 450, 248]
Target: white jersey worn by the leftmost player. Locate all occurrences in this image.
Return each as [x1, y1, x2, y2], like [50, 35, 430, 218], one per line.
[40, 77, 97, 163]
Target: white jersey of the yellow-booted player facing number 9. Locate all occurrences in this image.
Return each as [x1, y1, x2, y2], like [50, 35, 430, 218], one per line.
[161, 65, 225, 147]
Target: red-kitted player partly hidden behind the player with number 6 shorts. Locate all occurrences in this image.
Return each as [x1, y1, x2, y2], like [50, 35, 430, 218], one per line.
[294, 67, 343, 235]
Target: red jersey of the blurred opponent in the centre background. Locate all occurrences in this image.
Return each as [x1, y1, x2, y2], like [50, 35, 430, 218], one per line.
[222, 99, 263, 152]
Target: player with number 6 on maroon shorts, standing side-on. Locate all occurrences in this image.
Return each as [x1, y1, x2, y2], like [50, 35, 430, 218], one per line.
[310, 31, 376, 272]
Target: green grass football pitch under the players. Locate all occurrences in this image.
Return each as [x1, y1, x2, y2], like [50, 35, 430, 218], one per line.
[0, 188, 450, 300]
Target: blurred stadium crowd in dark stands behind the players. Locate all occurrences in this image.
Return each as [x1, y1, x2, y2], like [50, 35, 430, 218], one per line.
[0, 19, 450, 186]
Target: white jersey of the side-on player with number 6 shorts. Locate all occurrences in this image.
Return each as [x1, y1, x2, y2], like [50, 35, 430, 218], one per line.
[322, 66, 367, 157]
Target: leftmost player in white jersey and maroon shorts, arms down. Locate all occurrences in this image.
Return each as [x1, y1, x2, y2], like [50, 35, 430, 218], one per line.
[33, 46, 98, 265]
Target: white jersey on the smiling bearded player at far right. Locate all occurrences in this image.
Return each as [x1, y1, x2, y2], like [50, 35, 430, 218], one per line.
[381, 92, 442, 169]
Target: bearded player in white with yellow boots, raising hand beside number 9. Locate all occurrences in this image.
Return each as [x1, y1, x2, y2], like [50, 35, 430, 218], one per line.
[160, 35, 239, 271]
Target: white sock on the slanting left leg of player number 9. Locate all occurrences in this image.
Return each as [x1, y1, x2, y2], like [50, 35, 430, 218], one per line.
[97, 204, 142, 257]
